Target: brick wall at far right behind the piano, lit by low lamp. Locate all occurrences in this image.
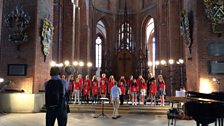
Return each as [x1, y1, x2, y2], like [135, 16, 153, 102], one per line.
[184, 0, 224, 93]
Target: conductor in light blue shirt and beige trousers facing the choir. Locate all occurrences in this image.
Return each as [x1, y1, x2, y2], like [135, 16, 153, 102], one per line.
[111, 83, 121, 119]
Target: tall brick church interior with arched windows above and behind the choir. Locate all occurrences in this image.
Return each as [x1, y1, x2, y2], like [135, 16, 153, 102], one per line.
[0, 0, 224, 113]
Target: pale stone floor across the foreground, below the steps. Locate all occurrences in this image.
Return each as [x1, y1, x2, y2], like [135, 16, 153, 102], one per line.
[0, 113, 201, 126]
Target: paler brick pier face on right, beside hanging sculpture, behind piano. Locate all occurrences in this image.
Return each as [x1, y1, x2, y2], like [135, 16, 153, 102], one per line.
[183, 0, 199, 91]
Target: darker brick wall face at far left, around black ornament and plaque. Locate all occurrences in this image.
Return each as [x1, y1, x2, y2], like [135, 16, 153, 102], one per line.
[0, 0, 37, 92]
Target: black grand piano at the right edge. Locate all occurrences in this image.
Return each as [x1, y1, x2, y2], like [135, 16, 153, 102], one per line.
[184, 92, 224, 126]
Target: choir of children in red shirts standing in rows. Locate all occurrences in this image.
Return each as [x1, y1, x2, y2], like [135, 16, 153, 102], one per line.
[62, 73, 166, 106]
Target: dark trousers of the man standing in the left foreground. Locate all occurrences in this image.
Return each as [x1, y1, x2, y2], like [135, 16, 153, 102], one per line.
[46, 105, 68, 126]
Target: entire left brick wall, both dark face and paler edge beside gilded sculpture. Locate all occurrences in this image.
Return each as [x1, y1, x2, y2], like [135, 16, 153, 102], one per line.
[0, 0, 53, 93]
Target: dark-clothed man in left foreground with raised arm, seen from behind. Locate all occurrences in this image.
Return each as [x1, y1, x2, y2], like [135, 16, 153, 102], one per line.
[45, 67, 71, 126]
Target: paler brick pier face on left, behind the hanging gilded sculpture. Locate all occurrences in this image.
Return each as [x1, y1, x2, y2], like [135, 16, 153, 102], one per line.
[32, 0, 54, 93]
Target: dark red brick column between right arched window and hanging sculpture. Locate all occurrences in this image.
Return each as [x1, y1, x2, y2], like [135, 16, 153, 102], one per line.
[167, 0, 184, 96]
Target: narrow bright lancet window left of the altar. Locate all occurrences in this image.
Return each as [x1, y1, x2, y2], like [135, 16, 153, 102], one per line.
[95, 36, 102, 68]
